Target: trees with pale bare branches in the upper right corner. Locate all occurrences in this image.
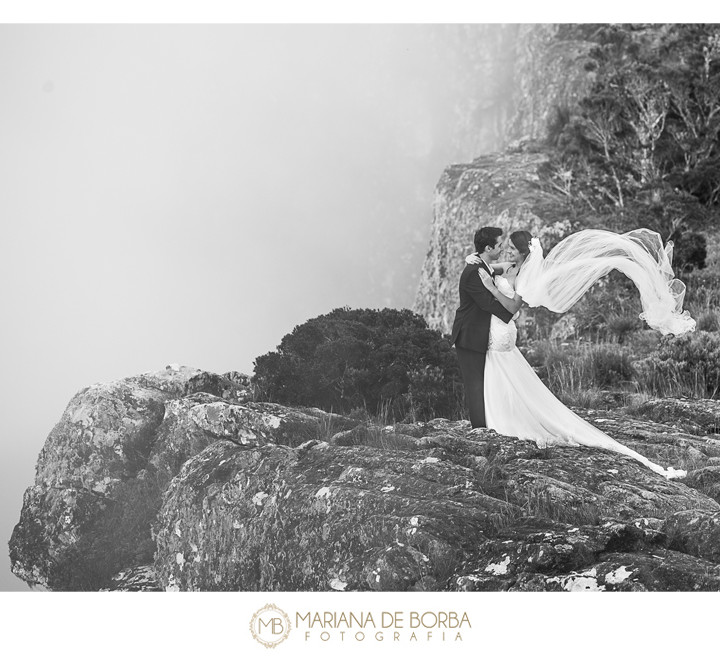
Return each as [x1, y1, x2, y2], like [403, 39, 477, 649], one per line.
[549, 25, 720, 228]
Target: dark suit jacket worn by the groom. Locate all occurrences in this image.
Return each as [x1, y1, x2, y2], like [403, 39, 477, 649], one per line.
[450, 263, 513, 352]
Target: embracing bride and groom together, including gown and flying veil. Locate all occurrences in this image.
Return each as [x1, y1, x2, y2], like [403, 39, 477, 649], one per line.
[451, 227, 695, 478]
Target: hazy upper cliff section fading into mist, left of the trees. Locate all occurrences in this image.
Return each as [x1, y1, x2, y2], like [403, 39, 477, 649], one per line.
[438, 23, 595, 160]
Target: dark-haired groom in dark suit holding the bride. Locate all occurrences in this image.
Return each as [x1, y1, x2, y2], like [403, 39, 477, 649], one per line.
[450, 226, 513, 428]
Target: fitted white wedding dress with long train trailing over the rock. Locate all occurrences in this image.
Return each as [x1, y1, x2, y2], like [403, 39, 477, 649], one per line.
[485, 276, 687, 478]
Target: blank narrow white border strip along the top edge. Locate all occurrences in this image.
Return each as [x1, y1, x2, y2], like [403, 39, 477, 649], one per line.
[0, 0, 720, 23]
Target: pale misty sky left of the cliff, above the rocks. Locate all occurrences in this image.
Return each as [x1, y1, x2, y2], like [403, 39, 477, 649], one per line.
[0, 25, 496, 589]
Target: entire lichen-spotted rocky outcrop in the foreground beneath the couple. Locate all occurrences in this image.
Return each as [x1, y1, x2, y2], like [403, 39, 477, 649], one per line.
[10, 368, 720, 591]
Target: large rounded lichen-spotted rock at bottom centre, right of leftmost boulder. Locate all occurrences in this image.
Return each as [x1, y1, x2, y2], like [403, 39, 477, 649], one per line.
[156, 442, 509, 590]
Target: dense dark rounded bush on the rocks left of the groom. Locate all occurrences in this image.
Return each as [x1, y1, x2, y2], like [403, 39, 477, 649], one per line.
[253, 308, 462, 420]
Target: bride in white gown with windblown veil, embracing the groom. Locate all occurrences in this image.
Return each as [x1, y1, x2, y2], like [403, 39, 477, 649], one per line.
[466, 229, 695, 478]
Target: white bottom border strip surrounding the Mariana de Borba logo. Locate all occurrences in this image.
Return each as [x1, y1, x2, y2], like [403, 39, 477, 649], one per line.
[0, 592, 718, 658]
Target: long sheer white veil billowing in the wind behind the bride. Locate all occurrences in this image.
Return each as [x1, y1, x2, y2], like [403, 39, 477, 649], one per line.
[516, 229, 695, 336]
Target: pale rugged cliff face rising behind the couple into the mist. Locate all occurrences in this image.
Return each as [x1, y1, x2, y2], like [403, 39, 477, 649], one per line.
[413, 24, 595, 333]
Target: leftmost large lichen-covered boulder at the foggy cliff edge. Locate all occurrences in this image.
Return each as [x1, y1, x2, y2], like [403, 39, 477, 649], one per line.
[10, 366, 256, 590]
